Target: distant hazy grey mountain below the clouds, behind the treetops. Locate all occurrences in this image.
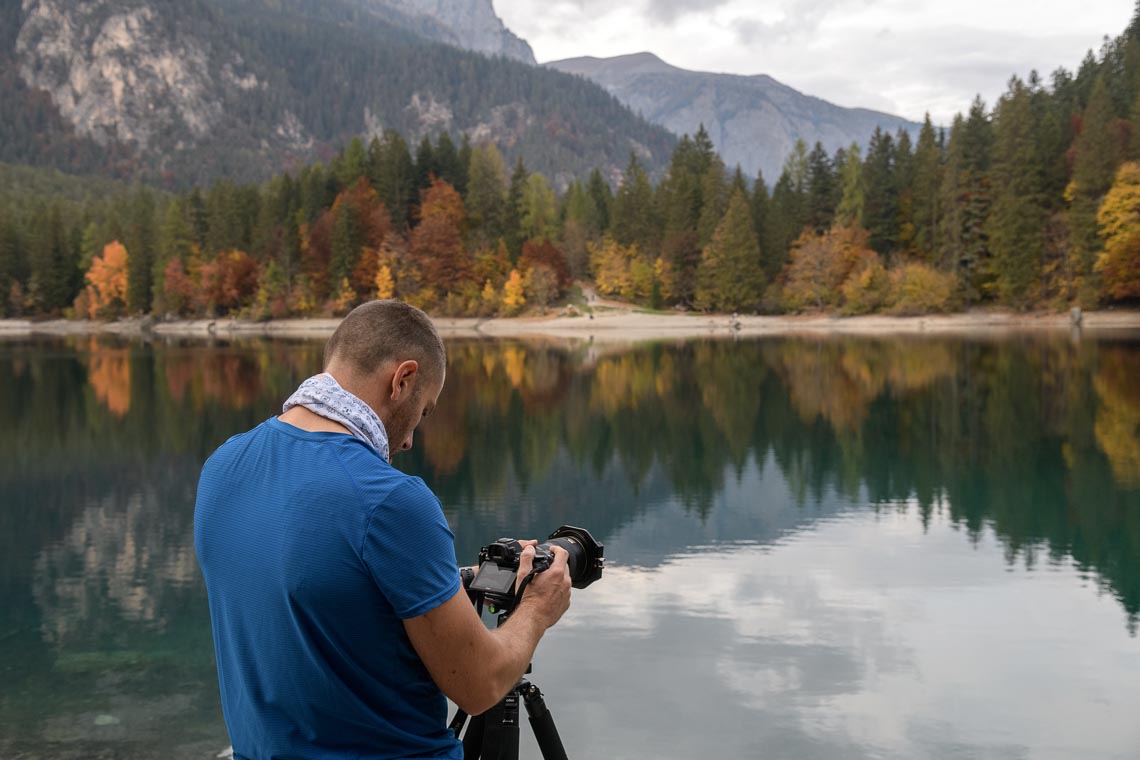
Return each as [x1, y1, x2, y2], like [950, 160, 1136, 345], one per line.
[545, 52, 920, 183]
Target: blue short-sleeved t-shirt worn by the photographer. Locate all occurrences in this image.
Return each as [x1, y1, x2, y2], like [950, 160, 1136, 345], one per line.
[194, 418, 463, 759]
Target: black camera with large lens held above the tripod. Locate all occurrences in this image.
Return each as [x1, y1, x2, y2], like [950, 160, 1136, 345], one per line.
[464, 525, 605, 613]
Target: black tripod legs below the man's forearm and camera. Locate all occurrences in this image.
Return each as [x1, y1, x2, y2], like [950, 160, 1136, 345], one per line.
[450, 668, 567, 760]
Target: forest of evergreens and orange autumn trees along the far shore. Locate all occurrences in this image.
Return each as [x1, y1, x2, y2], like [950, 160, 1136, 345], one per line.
[0, 8, 1140, 319]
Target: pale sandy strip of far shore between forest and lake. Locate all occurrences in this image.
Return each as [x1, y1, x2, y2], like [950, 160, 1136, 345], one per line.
[0, 310, 1140, 342]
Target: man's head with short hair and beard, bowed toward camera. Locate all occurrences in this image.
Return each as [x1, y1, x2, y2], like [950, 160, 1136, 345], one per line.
[325, 300, 447, 452]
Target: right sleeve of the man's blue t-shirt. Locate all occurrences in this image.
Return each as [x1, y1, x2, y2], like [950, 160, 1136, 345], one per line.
[360, 477, 459, 620]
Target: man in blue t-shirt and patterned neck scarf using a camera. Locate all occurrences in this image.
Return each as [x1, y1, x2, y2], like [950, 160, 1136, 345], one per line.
[194, 301, 570, 759]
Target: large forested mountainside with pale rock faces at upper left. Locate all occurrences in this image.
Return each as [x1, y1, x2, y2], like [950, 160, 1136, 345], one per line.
[0, 0, 675, 188]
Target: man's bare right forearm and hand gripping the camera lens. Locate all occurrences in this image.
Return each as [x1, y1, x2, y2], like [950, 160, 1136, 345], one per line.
[404, 546, 570, 716]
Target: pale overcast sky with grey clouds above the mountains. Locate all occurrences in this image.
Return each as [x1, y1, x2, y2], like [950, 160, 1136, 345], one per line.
[494, 0, 1134, 123]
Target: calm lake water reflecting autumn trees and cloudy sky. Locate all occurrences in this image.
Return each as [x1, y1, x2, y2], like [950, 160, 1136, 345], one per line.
[0, 334, 1140, 760]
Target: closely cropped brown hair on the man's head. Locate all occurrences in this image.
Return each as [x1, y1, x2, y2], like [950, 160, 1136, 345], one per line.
[325, 299, 447, 377]
